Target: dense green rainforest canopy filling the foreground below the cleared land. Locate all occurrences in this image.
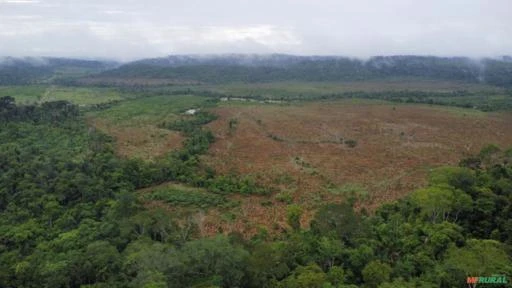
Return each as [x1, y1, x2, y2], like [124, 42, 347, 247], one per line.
[0, 97, 512, 288]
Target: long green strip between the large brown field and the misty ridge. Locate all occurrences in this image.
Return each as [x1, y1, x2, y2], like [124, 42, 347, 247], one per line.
[201, 78, 512, 111]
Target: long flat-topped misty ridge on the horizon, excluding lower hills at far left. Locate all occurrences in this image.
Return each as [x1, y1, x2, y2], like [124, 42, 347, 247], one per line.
[99, 54, 512, 87]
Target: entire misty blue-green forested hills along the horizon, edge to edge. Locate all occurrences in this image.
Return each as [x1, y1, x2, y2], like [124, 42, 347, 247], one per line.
[0, 54, 512, 88]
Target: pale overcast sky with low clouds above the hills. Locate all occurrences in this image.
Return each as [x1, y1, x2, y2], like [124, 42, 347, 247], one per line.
[0, 0, 512, 61]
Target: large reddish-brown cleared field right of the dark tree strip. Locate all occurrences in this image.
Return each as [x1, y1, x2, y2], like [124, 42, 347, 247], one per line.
[187, 101, 512, 233]
